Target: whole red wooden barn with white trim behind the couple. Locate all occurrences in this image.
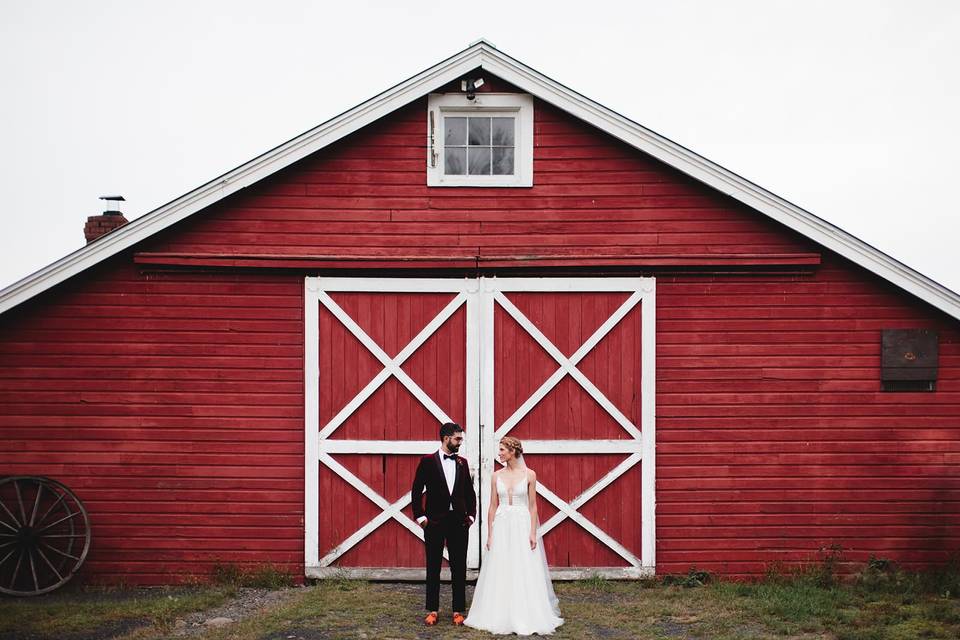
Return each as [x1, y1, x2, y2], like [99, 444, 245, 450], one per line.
[0, 42, 960, 584]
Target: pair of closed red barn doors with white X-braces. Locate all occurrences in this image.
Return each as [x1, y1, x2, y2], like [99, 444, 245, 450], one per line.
[304, 278, 655, 578]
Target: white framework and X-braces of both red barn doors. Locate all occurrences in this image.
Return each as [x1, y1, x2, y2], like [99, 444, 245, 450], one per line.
[304, 277, 656, 579]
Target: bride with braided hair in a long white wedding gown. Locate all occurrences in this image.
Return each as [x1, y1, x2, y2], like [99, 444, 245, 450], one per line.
[464, 436, 563, 635]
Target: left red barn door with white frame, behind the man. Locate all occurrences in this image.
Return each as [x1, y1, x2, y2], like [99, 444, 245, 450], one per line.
[304, 278, 479, 577]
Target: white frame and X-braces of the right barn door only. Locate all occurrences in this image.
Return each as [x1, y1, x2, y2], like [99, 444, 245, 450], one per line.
[480, 278, 656, 579]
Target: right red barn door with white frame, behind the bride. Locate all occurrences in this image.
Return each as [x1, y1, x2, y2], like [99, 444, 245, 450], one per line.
[480, 278, 656, 578]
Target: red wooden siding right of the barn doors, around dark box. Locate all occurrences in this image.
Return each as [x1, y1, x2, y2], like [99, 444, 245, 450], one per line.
[657, 259, 960, 574]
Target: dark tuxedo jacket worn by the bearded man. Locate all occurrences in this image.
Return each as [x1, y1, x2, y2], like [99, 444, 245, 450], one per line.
[410, 451, 477, 524]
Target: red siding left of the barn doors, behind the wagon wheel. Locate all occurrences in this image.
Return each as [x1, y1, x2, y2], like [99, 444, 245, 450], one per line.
[0, 255, 303, 584]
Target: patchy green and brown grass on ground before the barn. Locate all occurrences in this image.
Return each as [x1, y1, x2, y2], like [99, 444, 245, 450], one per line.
[0, 560, 960, 640]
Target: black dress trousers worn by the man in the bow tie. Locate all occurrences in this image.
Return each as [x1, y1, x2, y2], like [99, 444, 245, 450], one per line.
[424, 512, 470, 614]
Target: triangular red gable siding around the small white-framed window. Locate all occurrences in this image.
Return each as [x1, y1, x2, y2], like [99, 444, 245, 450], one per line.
[145, 100, 811, 258]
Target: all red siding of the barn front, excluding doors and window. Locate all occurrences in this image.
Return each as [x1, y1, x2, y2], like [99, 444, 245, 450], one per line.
[0, 84, 960, 583]
